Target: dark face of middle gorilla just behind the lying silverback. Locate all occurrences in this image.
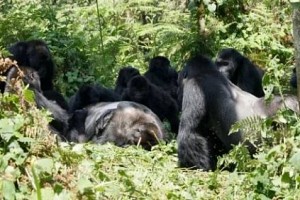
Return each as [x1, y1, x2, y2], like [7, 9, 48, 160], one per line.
[128, 76, 150, 102]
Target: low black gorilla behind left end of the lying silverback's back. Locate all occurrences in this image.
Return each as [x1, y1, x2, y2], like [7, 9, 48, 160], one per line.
[69, 84, 121, 113]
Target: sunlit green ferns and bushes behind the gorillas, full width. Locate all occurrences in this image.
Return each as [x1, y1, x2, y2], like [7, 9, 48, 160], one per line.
[0, 0, 292, 96]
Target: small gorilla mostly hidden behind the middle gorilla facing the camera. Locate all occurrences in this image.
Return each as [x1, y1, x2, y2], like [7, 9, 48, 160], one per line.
[115, 66, 140, 95]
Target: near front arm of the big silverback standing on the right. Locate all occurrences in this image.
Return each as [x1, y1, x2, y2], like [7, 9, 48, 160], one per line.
[177, 80, 211, 170]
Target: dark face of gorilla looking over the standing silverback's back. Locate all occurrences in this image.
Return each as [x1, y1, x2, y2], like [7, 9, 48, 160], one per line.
[216, 48, 242, 79]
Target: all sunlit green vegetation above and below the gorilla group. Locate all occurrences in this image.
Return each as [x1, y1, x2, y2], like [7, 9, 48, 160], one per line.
[0, 0, 300, 199]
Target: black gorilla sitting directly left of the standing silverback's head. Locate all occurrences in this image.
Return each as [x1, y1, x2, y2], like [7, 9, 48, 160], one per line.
[144, 56, 178, 100]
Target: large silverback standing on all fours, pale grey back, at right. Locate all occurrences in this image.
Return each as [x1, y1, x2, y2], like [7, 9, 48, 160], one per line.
[177, 55, 299, 170]
